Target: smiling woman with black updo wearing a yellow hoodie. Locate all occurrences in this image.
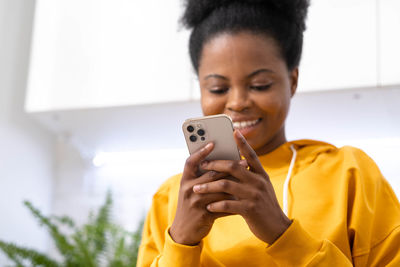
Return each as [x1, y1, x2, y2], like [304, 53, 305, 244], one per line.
[138, 0, 400, 266]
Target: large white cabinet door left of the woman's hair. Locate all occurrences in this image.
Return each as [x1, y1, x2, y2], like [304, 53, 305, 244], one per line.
[26, 0, 191, 111]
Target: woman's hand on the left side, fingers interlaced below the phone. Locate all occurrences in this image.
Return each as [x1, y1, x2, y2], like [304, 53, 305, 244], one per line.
[169, 143, 238, 245]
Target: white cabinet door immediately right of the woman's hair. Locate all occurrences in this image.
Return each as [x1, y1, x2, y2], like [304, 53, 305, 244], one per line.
[299, 0, 378, 91]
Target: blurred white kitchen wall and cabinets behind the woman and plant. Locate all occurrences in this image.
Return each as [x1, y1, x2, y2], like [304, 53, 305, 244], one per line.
[0, 0, 400, 266]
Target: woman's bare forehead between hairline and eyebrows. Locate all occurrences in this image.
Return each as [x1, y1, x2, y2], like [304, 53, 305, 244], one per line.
[199, 32, 286, 76]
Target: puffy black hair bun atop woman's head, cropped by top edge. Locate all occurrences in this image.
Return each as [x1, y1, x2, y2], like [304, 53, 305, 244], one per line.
[182, 0, 309, 30]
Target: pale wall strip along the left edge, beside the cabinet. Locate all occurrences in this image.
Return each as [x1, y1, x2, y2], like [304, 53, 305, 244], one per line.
[0, 0, 53, 266]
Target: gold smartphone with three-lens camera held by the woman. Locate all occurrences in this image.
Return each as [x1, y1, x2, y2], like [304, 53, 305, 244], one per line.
[182, 114, 240, 161]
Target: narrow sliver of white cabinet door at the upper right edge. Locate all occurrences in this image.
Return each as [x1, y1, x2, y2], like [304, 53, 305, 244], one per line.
[378, 0, 400, 85]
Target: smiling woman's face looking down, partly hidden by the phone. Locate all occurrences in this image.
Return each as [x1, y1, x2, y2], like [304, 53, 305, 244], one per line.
[198, 32, 298, 155]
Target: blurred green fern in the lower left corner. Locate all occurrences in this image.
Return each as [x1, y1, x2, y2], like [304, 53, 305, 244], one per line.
[0, 192, 143, 267]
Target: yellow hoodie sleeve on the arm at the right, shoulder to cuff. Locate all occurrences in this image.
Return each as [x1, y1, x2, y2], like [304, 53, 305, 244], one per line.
[267, 147, 400, 267]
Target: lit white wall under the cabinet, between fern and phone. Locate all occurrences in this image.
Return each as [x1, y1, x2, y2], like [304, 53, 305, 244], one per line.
[52, 140, 166, 234]
